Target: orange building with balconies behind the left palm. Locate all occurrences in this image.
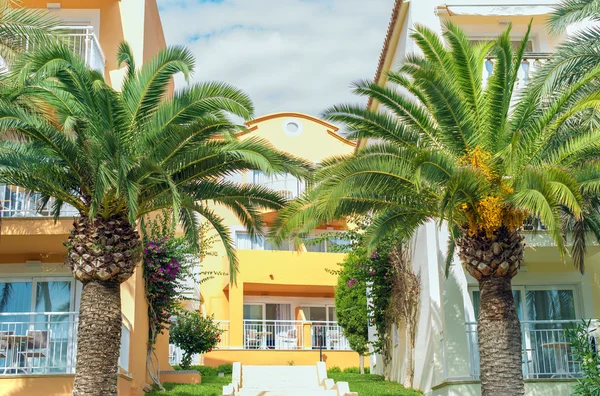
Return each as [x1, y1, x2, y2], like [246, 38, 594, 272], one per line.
[0, 0, 165, 396]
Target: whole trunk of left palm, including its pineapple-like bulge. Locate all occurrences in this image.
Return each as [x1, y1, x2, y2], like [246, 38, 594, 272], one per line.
[66, 216, 141, 396]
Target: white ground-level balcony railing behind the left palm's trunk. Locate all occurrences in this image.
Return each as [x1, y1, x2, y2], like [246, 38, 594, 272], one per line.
[0, 312, 131, 376]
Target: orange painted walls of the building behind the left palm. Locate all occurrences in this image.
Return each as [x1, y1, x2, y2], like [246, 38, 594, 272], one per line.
[0, 0, 168, 396]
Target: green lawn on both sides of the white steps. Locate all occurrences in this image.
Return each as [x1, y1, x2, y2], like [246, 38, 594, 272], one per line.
[147, 373, 421, 396]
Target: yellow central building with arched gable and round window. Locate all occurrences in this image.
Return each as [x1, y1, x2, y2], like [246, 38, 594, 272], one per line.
[171, 113, 359, 368]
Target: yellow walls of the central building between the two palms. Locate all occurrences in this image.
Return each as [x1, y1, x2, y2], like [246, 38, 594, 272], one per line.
[201, 113, 355, 356]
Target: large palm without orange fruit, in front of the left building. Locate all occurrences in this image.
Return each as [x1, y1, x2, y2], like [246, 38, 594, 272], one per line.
[0, 44, 307, 396]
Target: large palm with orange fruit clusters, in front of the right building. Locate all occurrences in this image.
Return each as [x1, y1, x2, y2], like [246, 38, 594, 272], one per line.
[273, 23, 600, 396]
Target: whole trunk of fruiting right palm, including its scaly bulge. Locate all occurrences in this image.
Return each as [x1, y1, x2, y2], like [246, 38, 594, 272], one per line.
[456, 226, 525, 396]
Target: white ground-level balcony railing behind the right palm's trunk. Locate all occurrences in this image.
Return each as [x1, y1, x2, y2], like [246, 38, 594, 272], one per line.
[466, 320, 599, 379]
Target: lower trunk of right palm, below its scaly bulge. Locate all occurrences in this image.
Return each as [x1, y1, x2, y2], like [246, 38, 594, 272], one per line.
[477, 276, 525, 396]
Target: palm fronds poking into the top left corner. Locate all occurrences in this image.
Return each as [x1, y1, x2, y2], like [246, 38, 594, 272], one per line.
[0, 0, 60, 66]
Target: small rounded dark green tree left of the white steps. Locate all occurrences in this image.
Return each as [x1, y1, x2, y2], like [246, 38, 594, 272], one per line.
[169, 311, 222, 370]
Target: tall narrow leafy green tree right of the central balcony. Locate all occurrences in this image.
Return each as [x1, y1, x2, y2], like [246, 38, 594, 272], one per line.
[335, 248, 369, 374]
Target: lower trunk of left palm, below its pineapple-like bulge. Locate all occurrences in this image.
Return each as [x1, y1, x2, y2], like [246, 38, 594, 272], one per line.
[72, 280, 122, 396]
